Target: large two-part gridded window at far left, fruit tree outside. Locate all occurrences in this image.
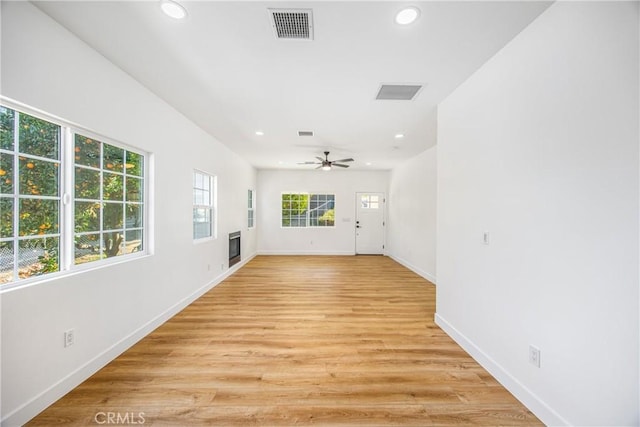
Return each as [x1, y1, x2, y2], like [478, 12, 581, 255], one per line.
[0, 106, 145, 285]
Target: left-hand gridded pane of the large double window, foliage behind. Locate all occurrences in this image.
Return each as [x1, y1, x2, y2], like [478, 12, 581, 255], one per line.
[0, 107, 60, 284]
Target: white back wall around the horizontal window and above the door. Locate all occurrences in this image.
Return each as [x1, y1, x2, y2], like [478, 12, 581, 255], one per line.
[256, 170, 389, 255]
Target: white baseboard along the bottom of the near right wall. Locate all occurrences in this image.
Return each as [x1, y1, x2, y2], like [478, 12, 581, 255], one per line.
[435, 313, 571, 426]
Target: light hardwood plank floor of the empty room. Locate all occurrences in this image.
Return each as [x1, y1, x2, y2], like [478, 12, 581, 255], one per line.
[30, 256, 541, 426]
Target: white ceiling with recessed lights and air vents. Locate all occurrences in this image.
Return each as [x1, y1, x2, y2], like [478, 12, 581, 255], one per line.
[35, 1, 550, 170]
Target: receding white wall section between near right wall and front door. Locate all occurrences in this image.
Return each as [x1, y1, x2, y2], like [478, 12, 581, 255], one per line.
[387, 147, 437, 283]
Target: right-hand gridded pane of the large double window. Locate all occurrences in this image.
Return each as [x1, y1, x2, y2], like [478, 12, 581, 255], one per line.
[74, 133, 144, 264]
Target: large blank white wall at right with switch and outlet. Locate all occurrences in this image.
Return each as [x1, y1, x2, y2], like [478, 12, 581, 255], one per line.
[437, 2, 640, 425]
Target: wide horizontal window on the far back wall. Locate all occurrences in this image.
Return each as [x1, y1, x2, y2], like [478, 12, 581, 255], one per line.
[281, 193, 335, 227]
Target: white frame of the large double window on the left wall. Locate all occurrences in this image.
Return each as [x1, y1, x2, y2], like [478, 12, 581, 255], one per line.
[0, 96, 152, 293]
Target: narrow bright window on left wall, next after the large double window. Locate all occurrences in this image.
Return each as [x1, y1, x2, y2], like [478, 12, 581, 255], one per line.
[193, 171, 216, 240]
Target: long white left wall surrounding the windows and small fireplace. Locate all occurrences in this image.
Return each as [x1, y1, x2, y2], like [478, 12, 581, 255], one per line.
[1, 2, 257, 425]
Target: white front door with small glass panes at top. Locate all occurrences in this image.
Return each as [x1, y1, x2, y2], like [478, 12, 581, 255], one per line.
[356, 193, 385, 255]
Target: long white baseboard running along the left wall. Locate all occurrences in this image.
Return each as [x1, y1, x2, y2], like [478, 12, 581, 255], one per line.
[0, 253, 256, 427]
